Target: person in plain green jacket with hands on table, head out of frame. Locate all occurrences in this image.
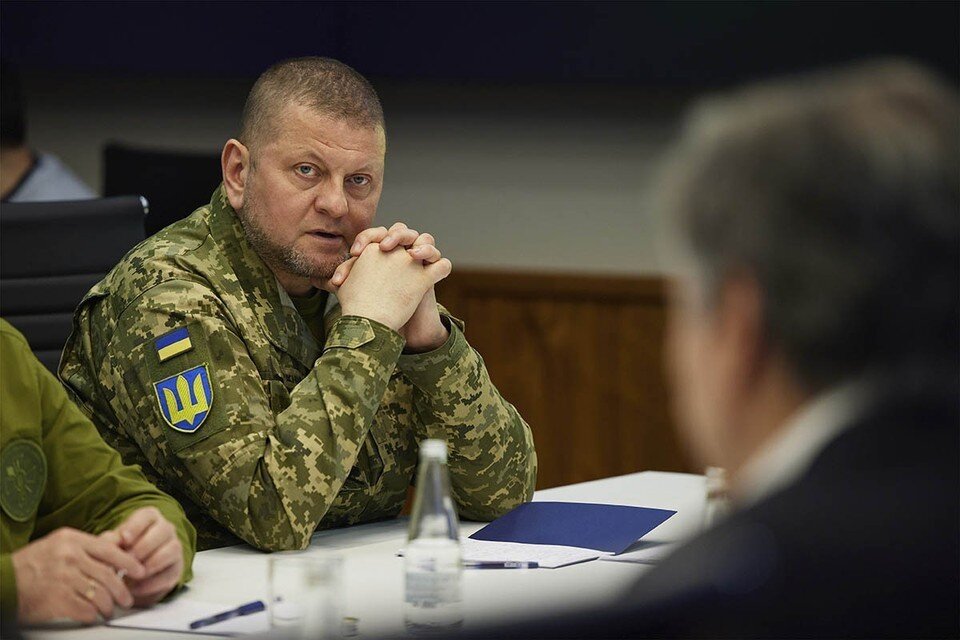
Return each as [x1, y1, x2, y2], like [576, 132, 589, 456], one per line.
[0, 319, 196, 625]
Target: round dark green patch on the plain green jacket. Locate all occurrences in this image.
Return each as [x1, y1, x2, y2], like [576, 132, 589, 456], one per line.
[0, 438, 47, 522]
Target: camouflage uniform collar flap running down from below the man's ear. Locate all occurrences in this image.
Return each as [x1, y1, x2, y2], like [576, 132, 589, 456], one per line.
[210, 184, 317, 369]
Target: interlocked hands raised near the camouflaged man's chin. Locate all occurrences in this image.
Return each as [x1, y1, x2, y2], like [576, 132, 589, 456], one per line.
[314, 222, 453, 352]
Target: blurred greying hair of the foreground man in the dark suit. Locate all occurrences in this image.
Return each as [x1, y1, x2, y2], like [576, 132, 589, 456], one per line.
[661, 61, 960, 391]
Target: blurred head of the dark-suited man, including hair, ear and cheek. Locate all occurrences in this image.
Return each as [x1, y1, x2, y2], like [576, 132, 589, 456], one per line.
[660, 60, 960, 480]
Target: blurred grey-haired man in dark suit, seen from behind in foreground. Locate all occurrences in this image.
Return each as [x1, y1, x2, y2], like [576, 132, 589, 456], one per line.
[480, 62, 960, 638]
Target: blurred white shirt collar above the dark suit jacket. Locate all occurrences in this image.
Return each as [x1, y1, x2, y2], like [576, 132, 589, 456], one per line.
[734, 381, 869, 509]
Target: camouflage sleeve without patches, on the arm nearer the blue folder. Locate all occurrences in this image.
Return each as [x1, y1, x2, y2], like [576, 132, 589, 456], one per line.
[398, 309, 537, 520]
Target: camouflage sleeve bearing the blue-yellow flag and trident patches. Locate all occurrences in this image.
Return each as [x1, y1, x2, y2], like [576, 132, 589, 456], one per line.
[101, 280, 403, 550]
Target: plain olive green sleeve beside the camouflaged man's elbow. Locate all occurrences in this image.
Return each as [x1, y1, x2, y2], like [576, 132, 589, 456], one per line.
[23, 342, 196, 582]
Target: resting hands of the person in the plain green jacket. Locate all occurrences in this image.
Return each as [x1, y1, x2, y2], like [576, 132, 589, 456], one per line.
[11, 507, 184, 625]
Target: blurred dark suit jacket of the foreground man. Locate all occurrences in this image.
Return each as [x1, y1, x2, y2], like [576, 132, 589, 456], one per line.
[471, 385, 960, 638]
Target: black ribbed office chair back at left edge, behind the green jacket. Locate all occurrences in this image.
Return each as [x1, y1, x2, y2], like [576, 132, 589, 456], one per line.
[0, 196, 147, 373]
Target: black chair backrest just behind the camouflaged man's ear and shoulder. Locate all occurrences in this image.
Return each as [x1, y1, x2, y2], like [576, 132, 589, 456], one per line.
[103, 143, 221, 236]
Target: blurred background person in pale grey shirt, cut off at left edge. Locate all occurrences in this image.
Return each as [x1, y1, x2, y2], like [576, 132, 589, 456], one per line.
[0, 61, 96, 202]
